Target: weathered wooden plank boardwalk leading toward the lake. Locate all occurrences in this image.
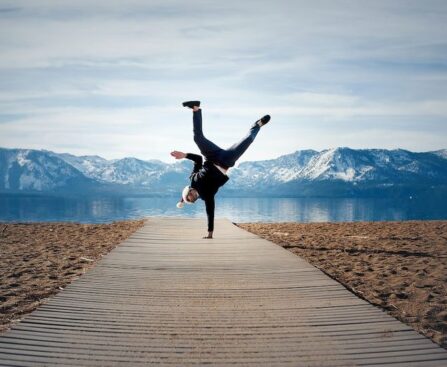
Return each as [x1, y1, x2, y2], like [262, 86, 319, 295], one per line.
[0, 218, 447, 366]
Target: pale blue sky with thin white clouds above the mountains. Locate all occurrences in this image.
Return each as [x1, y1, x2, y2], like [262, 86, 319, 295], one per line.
[0, 0, 447, 162]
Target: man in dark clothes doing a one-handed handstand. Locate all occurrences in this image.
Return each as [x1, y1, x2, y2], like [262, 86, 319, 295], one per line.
[171, 101, 270, 238]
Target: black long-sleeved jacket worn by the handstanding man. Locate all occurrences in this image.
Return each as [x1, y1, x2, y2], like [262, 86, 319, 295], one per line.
[186, 153, 229, 232]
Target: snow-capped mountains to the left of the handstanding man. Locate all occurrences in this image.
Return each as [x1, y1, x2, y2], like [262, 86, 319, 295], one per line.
[0, 148, 191, 195]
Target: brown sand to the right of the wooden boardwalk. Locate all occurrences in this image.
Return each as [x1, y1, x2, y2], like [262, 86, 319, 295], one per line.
[238, 221, 447, 348]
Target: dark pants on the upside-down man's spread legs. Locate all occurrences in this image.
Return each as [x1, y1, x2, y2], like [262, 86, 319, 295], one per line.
[193, 110, 261, 168]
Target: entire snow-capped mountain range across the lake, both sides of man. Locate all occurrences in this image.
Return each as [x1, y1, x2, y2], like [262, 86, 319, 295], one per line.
[0, 148, 447, 196]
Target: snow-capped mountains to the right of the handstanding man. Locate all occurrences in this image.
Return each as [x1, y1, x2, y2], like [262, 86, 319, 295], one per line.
[229, 148, 447, 190]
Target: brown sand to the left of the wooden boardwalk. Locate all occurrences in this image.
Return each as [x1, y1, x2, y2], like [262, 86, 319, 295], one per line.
[0, 220, 144, 332]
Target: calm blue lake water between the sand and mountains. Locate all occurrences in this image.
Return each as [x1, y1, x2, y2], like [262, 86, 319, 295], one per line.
[0, 195, 447, 223]
